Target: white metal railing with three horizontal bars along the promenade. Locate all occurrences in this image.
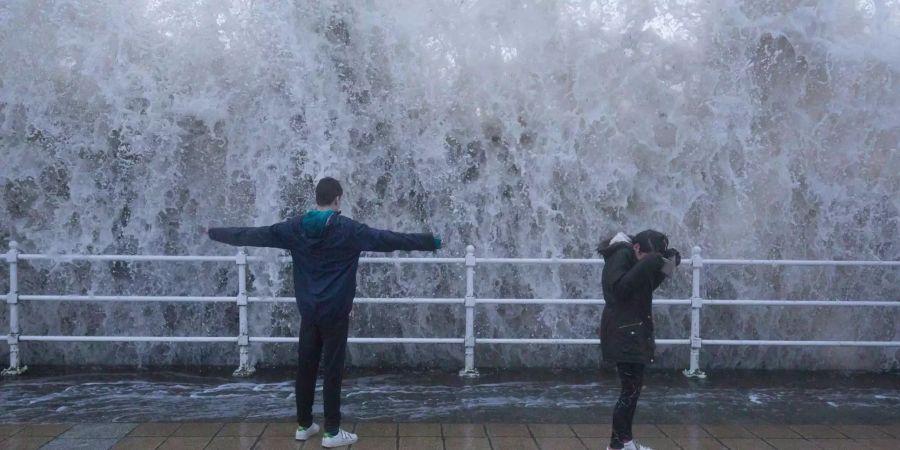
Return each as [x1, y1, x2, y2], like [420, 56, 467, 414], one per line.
[0, 241, 900, 377]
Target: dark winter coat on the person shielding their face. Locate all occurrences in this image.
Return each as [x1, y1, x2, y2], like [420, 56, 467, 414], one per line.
[600, 242, 665, 364]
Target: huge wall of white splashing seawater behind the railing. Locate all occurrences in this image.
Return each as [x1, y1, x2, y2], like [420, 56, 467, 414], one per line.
[0, 0, 900, 370]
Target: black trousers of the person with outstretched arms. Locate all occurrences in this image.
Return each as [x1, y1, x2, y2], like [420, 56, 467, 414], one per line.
[294, 316, 350, 434]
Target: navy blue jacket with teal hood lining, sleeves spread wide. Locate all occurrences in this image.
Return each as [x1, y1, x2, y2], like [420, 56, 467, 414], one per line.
[209, 211, 440, 321]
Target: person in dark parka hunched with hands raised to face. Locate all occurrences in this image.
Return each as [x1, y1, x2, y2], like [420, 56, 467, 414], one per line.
[598, 230, 681, 450]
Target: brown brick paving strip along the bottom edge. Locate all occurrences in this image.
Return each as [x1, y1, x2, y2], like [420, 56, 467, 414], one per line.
[0, 422, 900, 450]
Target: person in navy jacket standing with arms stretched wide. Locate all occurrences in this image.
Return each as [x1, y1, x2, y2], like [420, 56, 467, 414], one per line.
[209, 177, 441, 448]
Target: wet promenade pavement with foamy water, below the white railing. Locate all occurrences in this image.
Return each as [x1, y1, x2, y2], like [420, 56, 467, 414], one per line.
[0, 370, 900, 450]
